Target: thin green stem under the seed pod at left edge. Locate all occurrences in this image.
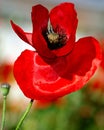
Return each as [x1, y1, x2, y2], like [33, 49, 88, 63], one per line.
[1, 96, 6, 130]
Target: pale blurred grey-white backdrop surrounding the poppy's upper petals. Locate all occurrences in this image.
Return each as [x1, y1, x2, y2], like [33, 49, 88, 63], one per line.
[0, 0, 104, 61]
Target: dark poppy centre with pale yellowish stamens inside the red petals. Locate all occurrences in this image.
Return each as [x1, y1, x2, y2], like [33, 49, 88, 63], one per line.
[44, 25, 67, 50]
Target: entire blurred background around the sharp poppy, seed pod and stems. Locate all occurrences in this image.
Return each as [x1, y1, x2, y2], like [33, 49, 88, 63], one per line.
[0, 0, 104, 130]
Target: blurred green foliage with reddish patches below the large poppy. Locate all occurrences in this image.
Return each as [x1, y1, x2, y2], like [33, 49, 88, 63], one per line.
[0, 81, 104, 130]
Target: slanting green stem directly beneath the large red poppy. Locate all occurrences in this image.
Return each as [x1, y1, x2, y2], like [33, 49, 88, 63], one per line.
[15, 100, 34, 130]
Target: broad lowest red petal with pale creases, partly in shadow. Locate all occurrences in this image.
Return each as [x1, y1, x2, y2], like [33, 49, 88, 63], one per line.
[14, 37, 101, 100]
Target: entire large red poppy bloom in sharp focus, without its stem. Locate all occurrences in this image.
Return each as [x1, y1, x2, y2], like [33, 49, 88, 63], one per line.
[11, 3, 101, 100]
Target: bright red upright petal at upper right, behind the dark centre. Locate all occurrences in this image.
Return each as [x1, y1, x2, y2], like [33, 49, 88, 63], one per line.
[50, 3, 78, 38]
